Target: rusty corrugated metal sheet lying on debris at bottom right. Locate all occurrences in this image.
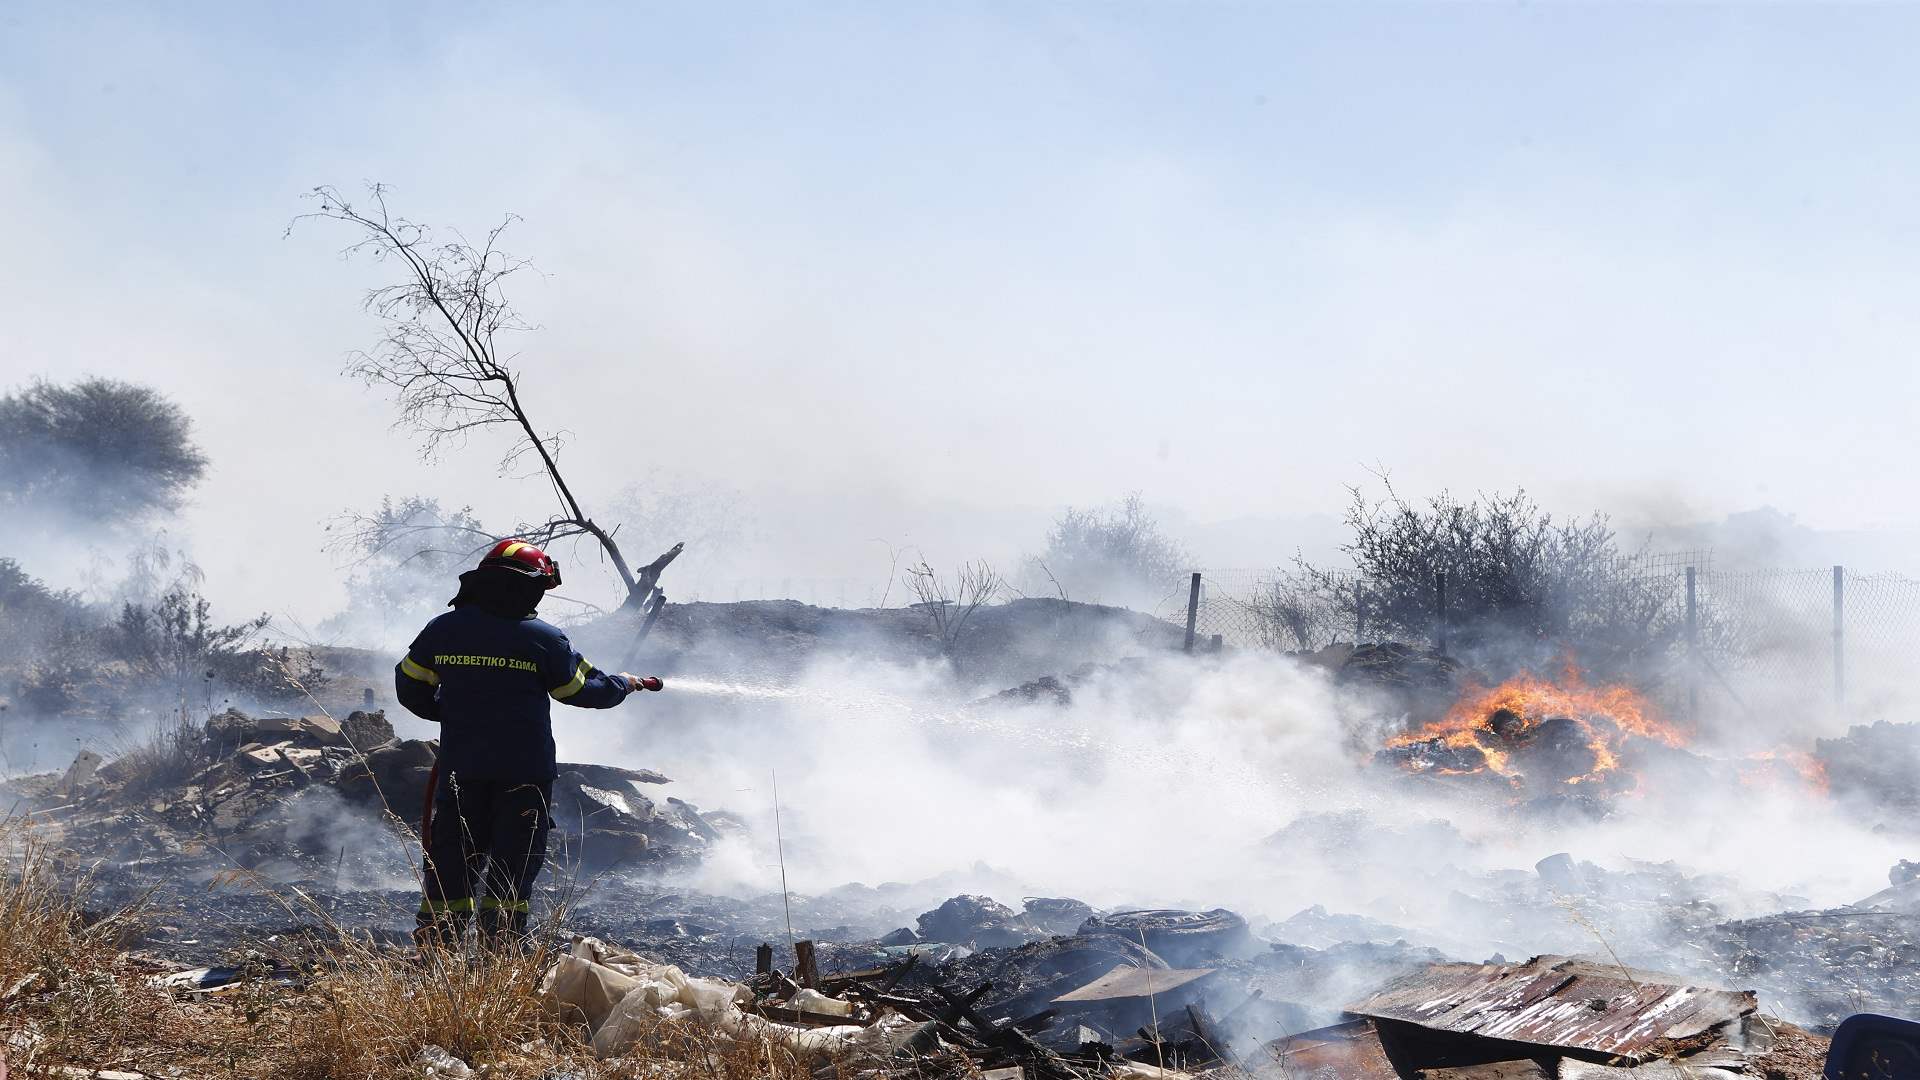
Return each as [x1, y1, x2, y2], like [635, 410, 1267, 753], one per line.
[1348, 957, 1757, 1065]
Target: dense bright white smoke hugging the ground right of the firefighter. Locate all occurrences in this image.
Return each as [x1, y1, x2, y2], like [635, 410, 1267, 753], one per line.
[576, 641, 1907, 959]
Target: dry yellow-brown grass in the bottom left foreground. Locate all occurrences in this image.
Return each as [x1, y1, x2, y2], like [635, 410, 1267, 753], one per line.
[0, 824, 848, 1080]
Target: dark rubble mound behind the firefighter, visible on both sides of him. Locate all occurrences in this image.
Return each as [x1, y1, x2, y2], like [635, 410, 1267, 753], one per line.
[0, 709, 733, 907]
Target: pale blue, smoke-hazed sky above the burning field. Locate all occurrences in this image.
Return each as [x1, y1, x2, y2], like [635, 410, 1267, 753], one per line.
[0, 2, 1920, 615]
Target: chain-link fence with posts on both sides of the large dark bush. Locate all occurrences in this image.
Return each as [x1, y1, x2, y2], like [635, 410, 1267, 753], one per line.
[1156, 552, 1920, 721]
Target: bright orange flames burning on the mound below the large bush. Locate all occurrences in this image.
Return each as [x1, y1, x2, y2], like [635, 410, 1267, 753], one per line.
[1388, 661, 1688, 784]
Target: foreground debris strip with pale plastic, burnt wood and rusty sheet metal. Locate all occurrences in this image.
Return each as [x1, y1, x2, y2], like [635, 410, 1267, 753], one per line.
[541, 934, 1824, 1080]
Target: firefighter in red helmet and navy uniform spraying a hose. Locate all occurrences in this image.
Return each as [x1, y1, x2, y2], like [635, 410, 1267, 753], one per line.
[394, 540, 660, 947]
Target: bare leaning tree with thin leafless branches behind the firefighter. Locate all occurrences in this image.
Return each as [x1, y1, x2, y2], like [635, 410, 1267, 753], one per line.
[296, 184, 682, 625]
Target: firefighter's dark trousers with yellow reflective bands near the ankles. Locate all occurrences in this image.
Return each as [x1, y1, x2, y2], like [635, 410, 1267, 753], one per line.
[415, 773, 553, 945]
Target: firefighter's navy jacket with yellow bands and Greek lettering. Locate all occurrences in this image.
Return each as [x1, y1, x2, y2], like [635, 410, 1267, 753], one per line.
[394, 603, 628, 782]
